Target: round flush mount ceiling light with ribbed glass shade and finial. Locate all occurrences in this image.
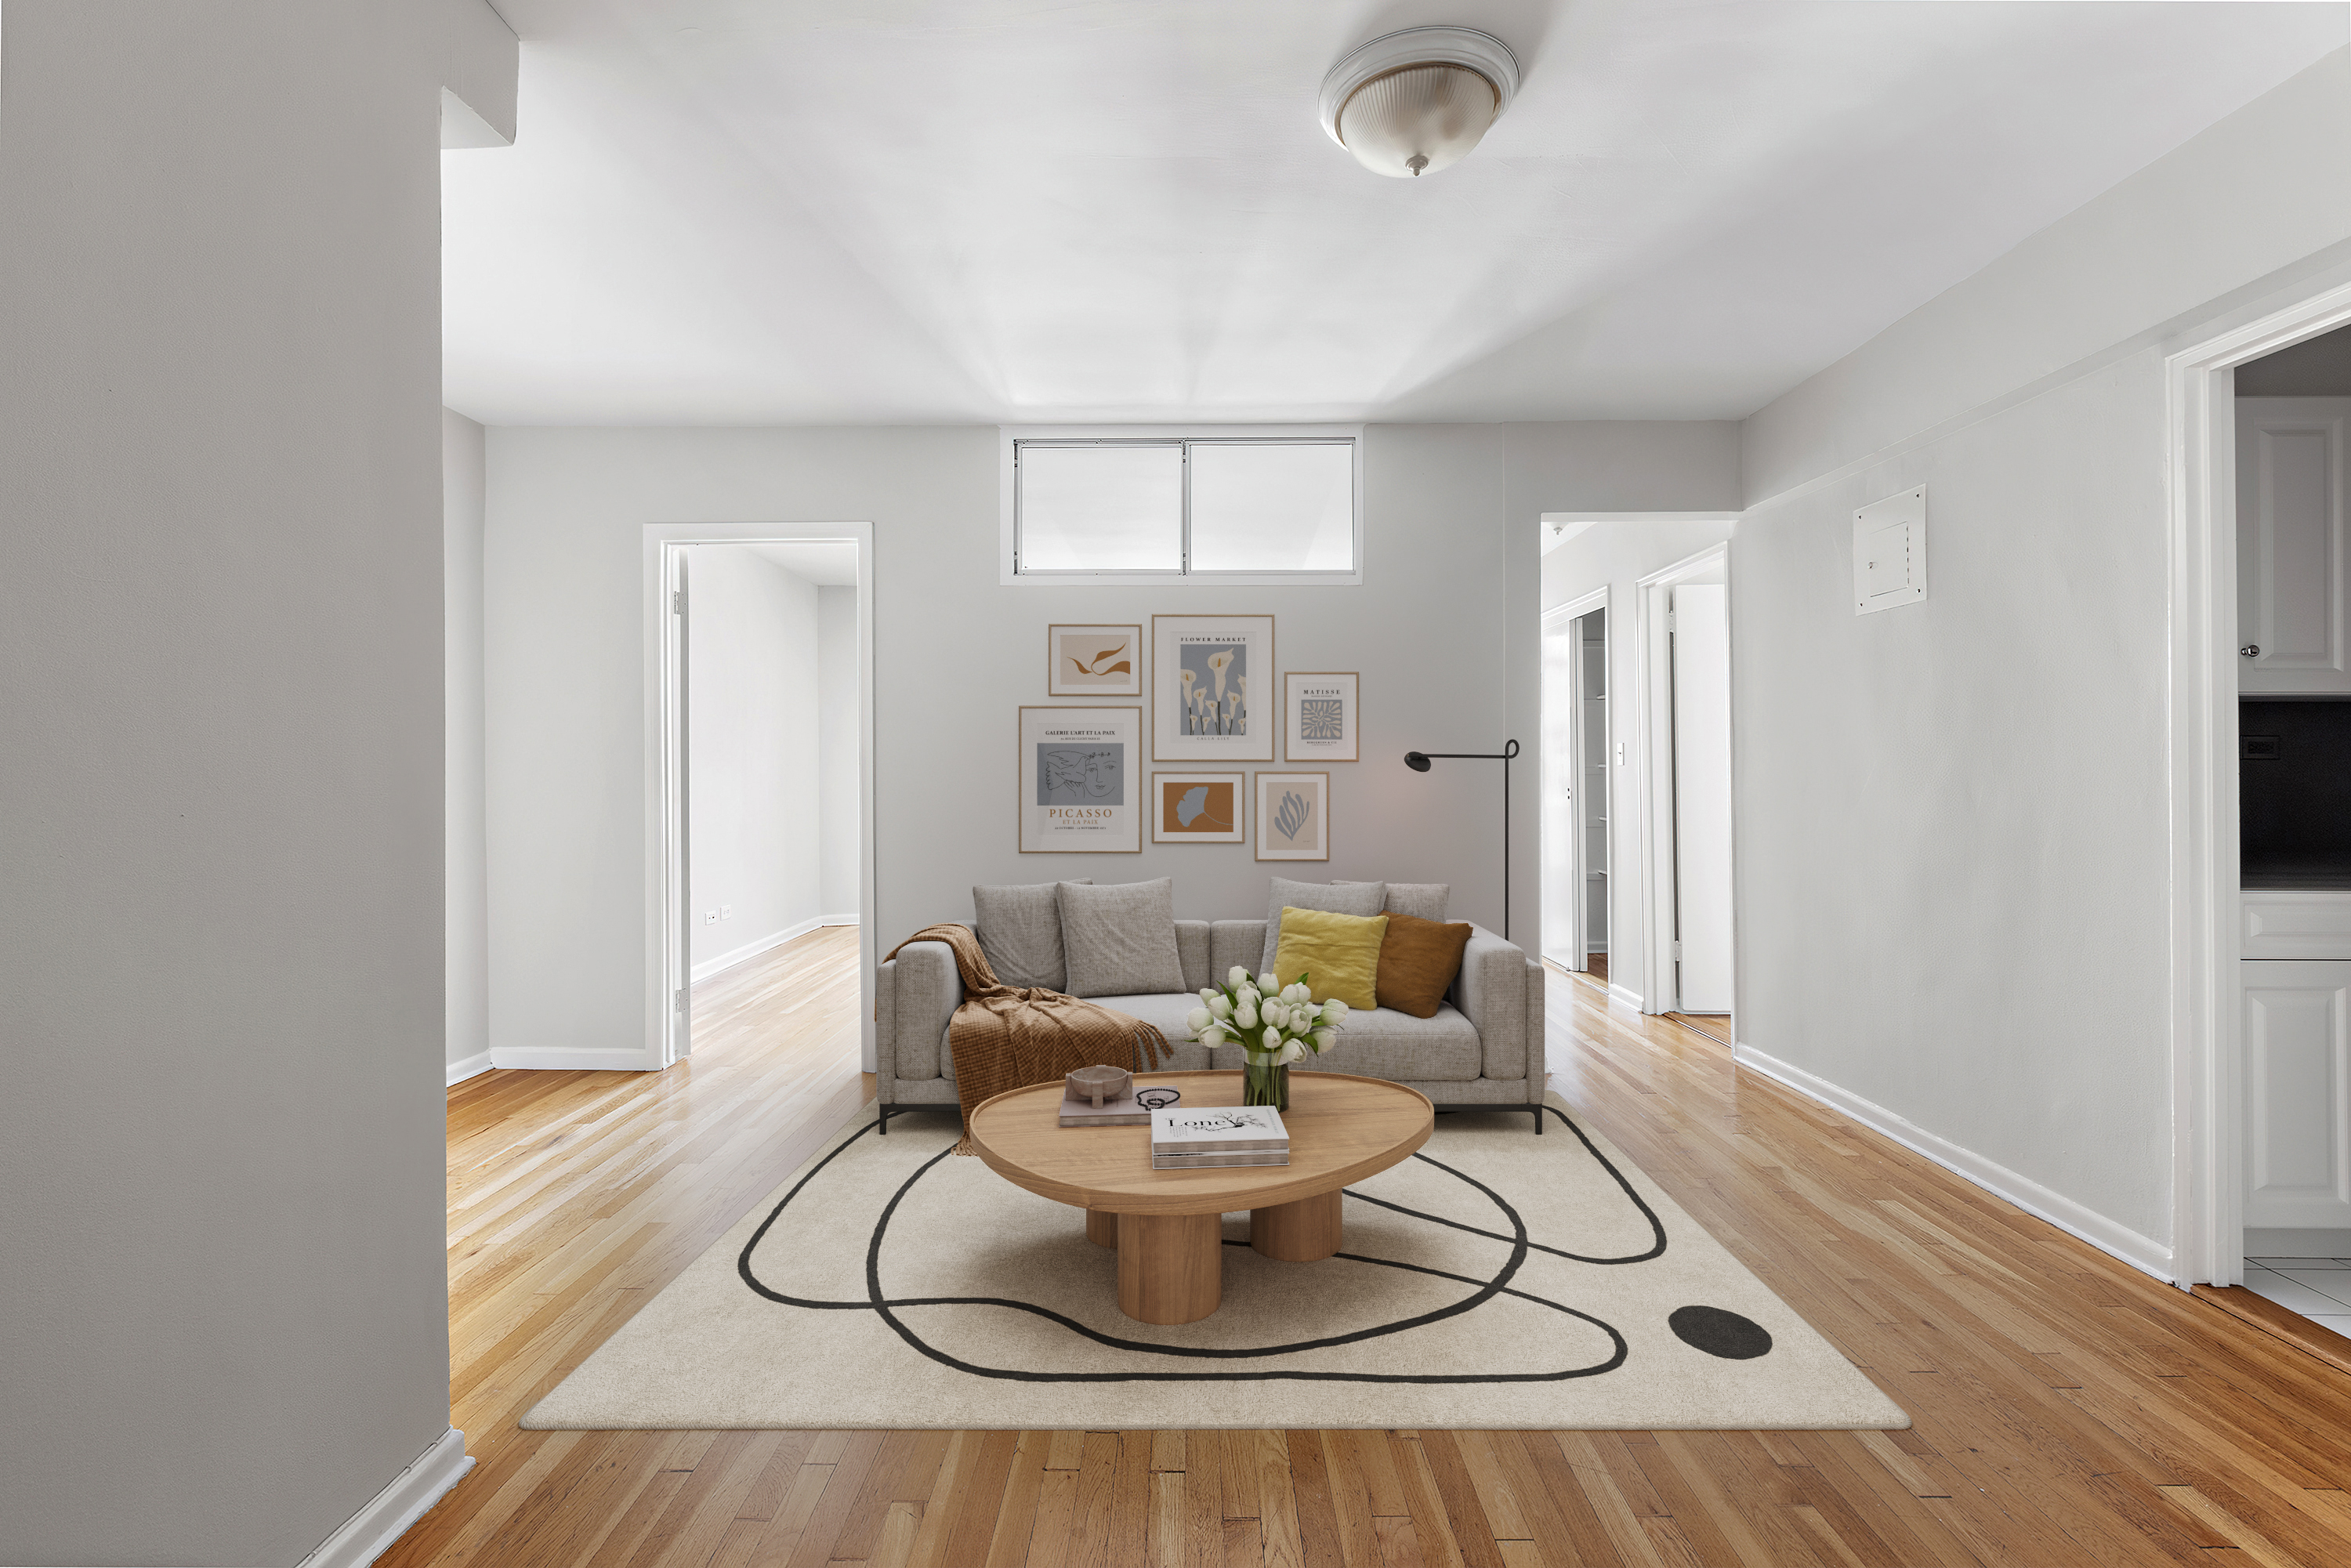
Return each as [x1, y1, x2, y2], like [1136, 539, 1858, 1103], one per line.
[1321, 28, 1519, 179]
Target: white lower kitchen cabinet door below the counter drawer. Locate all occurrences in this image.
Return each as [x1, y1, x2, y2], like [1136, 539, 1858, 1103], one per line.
[2243, 959, 2351, 1229]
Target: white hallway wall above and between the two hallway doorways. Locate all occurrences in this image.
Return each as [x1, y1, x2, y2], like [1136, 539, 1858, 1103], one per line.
[1542, 508, 1730, 1006]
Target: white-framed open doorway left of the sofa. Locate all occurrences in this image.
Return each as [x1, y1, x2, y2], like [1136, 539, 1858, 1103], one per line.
[647, 524, 875, 1070]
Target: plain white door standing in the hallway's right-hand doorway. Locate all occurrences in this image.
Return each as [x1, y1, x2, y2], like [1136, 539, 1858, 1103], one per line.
[1672, 583, 1730, 1013]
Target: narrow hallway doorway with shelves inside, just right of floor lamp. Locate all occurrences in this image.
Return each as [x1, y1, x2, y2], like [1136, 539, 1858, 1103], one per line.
[1542, 588, 1608, 987]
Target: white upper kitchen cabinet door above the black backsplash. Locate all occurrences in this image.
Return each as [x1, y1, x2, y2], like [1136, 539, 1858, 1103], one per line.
[2236, 397, 2351, 691]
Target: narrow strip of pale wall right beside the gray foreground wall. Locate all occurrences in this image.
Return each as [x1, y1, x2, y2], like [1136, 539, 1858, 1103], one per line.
[442, 409, 489, 1074]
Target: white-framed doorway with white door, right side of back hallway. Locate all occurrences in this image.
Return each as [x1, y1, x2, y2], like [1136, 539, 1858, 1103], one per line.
[1641, 545, 1735, 1016]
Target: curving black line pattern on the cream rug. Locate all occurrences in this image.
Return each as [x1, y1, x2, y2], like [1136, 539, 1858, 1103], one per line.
[736, 1105, 1665, 1385]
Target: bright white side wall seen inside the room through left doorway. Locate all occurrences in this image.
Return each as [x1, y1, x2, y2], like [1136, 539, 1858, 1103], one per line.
[686, 545, 825, 978]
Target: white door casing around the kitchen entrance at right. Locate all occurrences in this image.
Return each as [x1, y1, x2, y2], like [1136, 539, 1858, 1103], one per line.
[2163, 284, 2351, 1286]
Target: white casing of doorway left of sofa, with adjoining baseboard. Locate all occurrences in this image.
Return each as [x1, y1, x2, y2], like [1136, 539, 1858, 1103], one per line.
[649, 522, 877, 1072]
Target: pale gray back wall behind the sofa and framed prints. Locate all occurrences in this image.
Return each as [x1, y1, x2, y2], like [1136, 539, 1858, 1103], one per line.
[487, 425, 1737, 1067]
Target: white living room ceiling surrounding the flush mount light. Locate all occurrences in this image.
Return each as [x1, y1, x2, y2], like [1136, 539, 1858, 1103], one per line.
[442, 0, 2351, 423]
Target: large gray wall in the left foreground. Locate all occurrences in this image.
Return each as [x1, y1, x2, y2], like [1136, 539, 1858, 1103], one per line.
[0, 0, 513, 1566]
